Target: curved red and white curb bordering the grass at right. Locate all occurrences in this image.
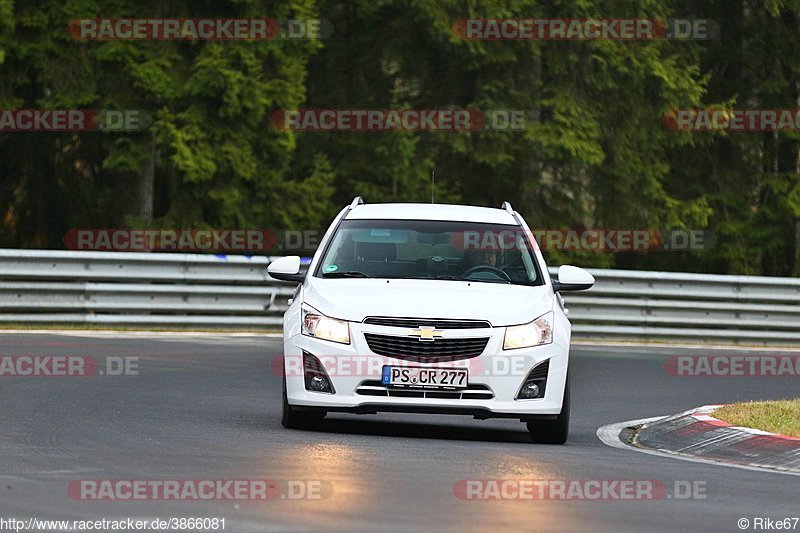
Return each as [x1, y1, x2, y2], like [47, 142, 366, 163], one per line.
[597, 405, 800, 475]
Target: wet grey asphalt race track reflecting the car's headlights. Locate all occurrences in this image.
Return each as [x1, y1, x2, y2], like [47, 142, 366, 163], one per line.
[0, 333, 800, 532]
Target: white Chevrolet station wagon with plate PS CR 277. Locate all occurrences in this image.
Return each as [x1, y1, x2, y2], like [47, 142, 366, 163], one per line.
[268, 197, 594, 444]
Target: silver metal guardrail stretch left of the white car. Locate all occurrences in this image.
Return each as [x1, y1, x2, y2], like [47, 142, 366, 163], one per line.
[0, 250, 282, 328]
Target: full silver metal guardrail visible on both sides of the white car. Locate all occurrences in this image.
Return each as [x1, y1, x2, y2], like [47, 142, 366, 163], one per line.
[0, 249, 800, 345]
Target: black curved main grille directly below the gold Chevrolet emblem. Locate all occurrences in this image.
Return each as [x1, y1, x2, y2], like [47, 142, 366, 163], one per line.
[364, 333, 489, 363]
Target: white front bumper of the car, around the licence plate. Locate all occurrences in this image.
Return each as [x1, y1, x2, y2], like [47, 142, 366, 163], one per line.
[283, 323, 569, 420]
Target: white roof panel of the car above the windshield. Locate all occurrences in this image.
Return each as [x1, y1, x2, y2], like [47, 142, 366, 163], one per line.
[345, 203, 519, 222]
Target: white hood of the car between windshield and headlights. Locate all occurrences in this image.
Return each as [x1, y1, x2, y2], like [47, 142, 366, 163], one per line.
[303, 277, 553, 326]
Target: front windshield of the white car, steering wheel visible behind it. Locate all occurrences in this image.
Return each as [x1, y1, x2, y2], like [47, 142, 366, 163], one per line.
[315, 216, 542, 285]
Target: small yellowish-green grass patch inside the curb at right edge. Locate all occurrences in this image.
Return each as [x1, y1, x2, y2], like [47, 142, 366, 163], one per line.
[712, 398, 800, 437]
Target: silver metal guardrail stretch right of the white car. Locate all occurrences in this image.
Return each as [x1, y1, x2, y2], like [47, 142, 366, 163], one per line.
[564, 269, 800, 345]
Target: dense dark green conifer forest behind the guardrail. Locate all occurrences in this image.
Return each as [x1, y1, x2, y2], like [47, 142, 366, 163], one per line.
[0, 0, 800, 276]
